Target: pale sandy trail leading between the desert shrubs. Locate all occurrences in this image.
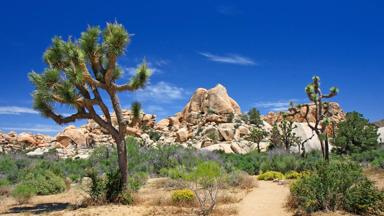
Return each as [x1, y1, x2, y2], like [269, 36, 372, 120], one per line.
[239, 181, 292, 216]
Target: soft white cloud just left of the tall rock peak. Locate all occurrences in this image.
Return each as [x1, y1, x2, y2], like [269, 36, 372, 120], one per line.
[136, 81, 186, 103]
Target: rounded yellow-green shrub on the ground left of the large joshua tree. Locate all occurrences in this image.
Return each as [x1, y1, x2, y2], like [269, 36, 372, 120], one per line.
[22, 169, 66, 195]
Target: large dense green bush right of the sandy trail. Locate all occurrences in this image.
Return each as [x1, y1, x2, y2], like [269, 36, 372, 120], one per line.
[290, 161, 383, 214]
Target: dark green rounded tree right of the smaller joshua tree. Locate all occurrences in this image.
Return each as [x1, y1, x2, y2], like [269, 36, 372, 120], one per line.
[333, 112, 379, 154]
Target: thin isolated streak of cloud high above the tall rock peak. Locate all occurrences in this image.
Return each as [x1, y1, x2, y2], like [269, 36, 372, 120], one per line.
[199, 52, 257, 65]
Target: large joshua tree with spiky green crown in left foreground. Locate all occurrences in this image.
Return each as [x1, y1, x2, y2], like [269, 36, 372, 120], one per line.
[29, 23, 151, 185]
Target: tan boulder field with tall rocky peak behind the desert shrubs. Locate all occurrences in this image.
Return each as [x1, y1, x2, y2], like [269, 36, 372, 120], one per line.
[0, 84, 376, 158]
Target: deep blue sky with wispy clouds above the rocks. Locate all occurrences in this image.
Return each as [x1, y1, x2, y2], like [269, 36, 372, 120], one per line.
[0, 0, 384, 134]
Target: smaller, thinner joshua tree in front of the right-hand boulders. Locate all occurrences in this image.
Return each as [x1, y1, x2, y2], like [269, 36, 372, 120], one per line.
[289, 76, 339, 160]
